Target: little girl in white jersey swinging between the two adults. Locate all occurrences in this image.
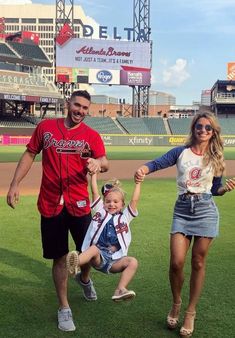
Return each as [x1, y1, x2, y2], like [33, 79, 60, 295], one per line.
[66, 174, 140, 301]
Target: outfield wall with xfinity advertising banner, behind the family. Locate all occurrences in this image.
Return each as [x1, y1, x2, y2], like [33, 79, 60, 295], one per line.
[0, 134, 235, 147]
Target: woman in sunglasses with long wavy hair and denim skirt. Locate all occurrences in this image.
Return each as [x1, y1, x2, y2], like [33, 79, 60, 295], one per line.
[135, 113, 235, 337]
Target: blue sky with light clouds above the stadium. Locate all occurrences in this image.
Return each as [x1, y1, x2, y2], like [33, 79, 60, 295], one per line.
[0, 0, 235, 105]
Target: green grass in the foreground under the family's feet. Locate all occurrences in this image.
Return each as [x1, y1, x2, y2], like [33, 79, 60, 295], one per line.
[0, 179, 235, 338]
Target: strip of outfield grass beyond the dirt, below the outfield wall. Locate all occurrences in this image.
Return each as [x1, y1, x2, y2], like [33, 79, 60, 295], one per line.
[0, 146, 235, 162]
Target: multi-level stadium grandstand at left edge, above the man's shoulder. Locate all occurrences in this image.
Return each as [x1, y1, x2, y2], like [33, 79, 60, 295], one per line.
[0, 31, 64, 109]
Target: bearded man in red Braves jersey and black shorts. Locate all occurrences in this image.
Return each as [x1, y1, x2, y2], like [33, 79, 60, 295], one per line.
[7, 90, 108, 331]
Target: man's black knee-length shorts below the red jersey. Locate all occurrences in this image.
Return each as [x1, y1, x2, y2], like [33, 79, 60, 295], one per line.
[41, 207, 91, 259]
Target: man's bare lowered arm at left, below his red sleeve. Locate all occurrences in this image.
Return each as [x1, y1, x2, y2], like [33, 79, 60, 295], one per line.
[7, 150, 36, 209]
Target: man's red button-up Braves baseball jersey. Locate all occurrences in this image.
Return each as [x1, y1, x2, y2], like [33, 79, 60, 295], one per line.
[27, 118, 105, 217]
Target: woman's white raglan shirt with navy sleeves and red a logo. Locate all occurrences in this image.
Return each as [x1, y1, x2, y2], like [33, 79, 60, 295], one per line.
[145, 146, 222, 195]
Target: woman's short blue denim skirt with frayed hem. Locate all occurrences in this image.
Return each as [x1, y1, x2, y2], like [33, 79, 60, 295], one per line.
[171, 194, 219, 238]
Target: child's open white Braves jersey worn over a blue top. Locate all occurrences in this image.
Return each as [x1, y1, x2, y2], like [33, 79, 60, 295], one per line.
[82, 197, 138, 259]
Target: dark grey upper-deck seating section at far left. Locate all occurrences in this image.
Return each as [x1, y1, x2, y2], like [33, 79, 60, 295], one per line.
[0, 41, 52, 67]
